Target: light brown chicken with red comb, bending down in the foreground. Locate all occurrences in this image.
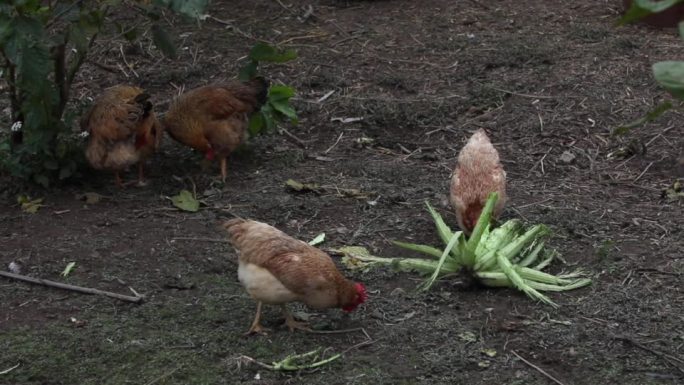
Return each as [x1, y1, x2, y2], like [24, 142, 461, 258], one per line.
[223, 219, 367, 334]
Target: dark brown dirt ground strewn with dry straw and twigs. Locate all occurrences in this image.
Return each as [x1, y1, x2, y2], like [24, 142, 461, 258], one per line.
[0, 0, 684, 385]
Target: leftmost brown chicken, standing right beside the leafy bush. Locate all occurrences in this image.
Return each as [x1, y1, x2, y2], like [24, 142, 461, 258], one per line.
[81, 85, 162, 187]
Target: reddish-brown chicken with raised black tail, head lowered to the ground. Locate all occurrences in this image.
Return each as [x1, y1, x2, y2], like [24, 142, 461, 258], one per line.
[163, 77, 269, 181]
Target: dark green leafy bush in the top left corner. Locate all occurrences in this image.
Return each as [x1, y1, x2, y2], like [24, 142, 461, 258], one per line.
[0, 0, 207, 186]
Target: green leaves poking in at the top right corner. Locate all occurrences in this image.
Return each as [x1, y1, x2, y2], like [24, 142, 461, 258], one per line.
[613, 0, 684, 135]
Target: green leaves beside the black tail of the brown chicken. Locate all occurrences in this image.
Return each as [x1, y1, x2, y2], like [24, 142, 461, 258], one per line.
[239, 43, 297, 135]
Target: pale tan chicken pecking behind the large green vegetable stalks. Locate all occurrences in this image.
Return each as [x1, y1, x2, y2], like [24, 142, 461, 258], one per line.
[450, 129, 506, 234]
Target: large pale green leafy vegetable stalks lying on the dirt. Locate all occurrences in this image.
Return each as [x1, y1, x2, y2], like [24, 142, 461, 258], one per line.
[337, 193, 591, 307]
